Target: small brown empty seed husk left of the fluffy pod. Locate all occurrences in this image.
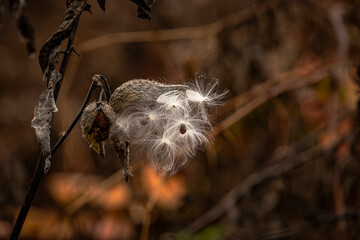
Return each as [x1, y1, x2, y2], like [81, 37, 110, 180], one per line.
[80, 102, 115, 157]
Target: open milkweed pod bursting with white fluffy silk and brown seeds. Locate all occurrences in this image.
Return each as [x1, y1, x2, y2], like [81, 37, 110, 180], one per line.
[110, 79, 226, 174]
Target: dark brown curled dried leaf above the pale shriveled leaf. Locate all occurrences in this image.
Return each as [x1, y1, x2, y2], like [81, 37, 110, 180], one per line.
[39, 1, 89, 72]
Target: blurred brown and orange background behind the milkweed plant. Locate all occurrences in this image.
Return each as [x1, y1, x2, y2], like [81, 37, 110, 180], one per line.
[0, 0, 360, 240]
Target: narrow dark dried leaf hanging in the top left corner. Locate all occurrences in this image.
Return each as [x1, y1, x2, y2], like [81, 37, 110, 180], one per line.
[8, 0, 35, 54]
